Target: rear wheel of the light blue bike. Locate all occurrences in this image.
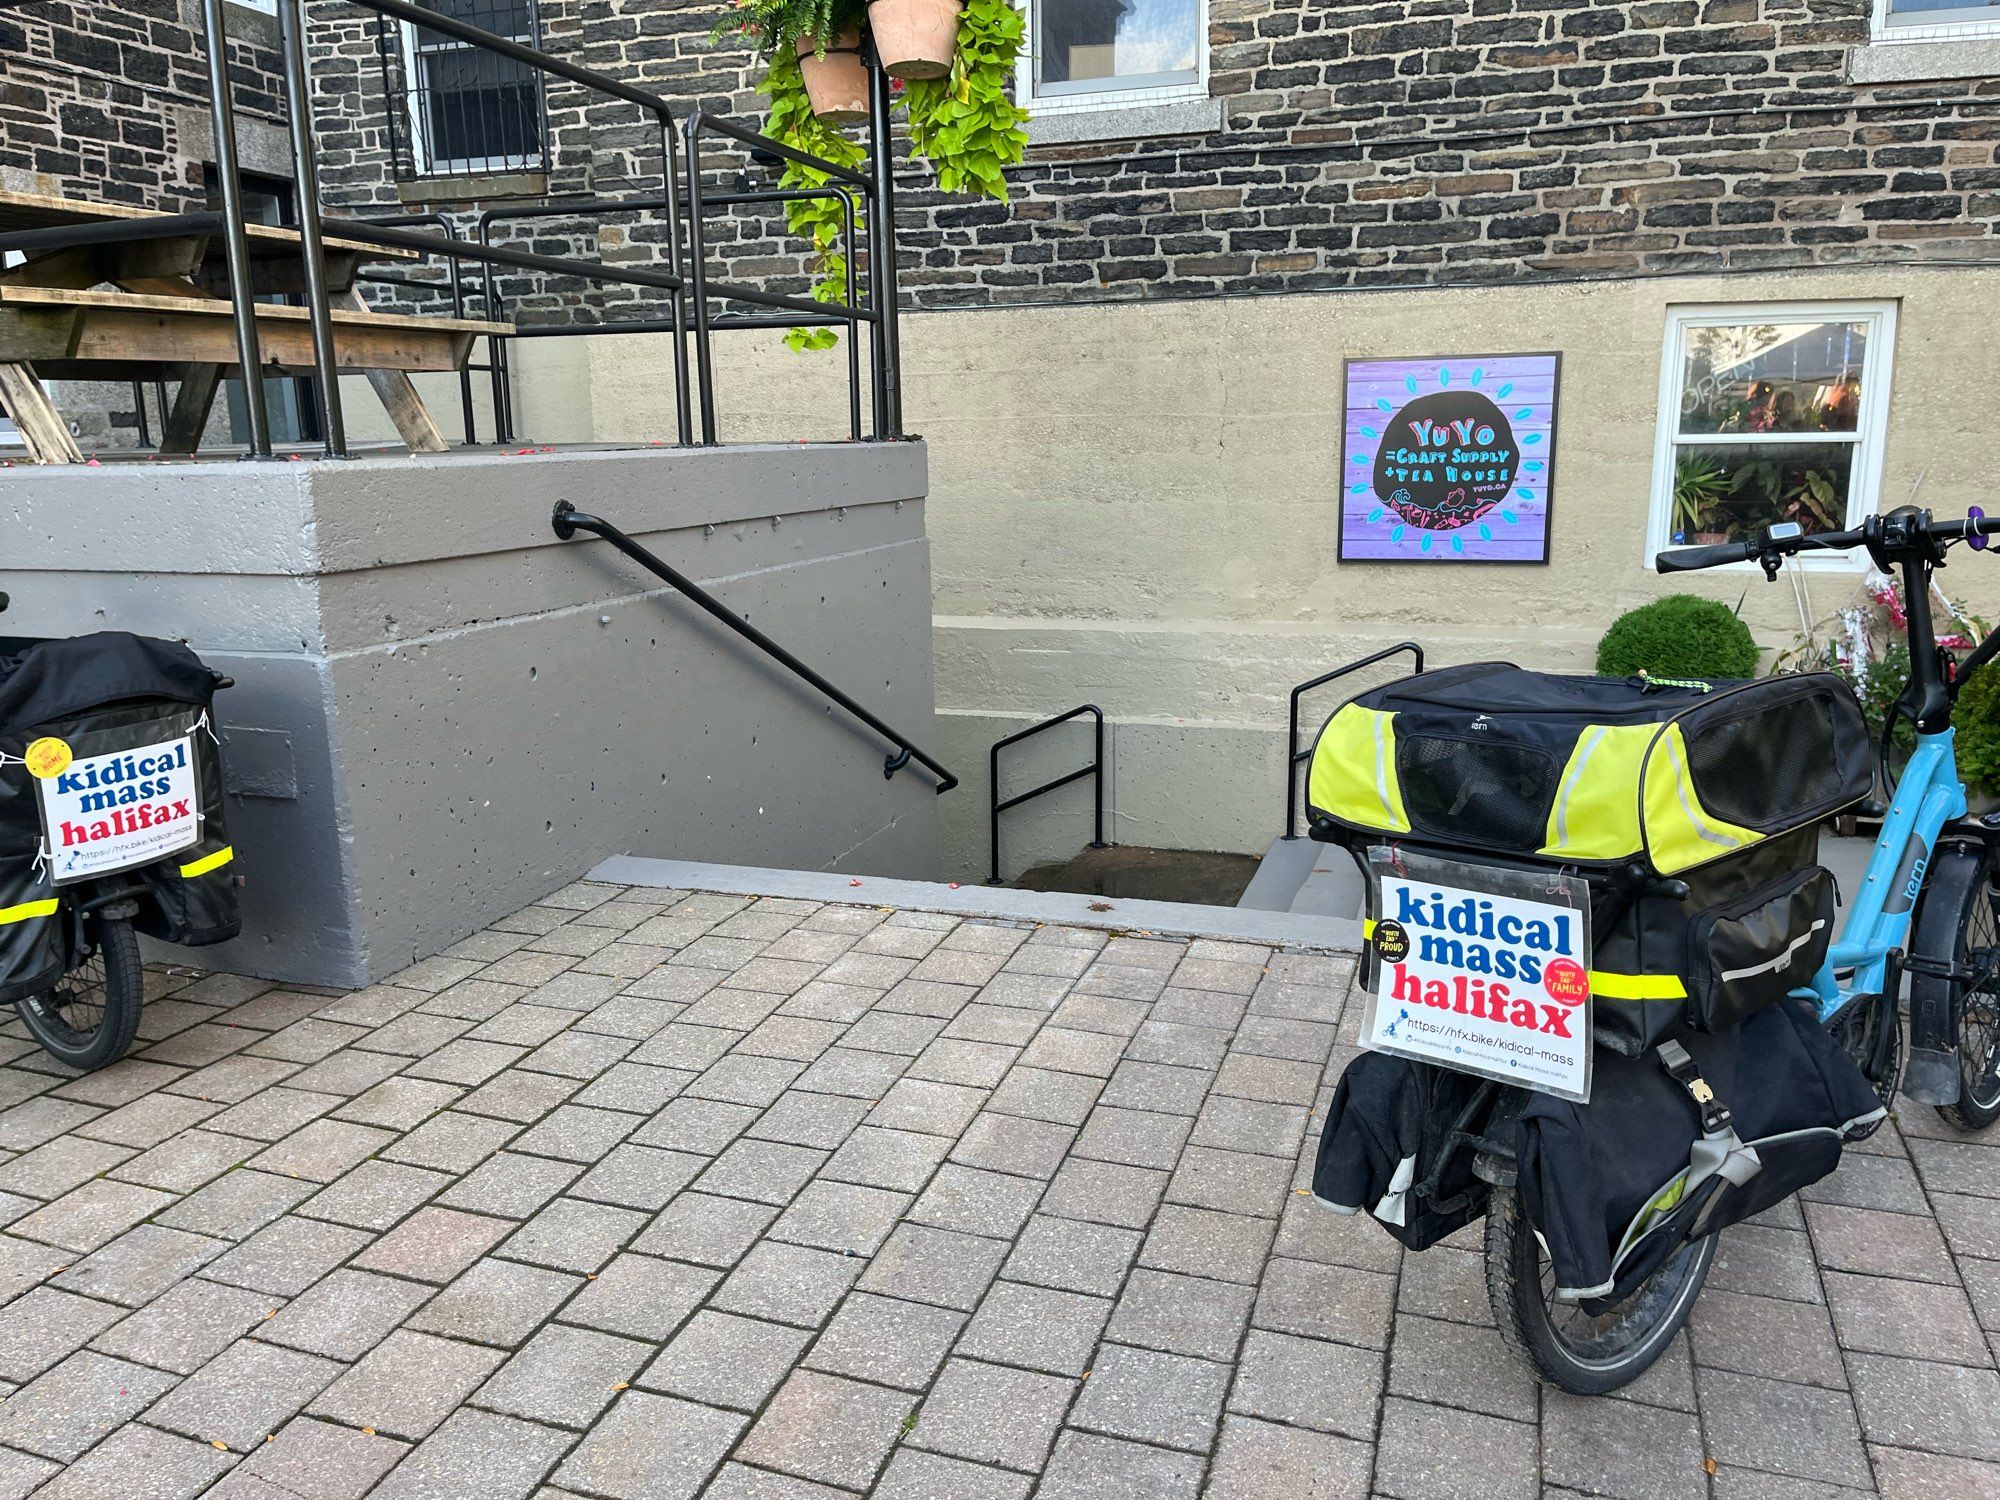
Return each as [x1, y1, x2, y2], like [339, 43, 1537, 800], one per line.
[1486, 1188, 1716, 1396]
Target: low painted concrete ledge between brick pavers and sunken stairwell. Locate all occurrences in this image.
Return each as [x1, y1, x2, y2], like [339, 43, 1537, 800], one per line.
[590, 854, 1362, 952]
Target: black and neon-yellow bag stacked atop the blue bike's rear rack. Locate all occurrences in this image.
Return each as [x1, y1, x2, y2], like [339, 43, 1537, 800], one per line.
[1308, 662, 1874, 1056]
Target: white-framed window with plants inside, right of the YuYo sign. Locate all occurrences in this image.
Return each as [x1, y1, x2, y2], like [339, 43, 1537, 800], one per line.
[1654, 304, 1894, 560]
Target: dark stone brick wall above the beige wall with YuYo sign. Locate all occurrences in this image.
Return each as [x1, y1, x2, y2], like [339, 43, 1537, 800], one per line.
[304, 0, 2000, 316]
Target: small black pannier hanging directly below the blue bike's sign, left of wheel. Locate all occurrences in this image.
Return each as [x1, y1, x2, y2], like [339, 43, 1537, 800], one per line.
[1312, 1052, 1494, 1250]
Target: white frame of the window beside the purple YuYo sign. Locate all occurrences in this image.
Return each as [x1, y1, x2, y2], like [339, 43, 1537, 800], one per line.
[1644, 302, 1898, 572]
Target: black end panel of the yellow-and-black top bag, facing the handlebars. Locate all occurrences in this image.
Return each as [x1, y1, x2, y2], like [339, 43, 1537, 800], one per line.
[1688, 694, 1844, 828]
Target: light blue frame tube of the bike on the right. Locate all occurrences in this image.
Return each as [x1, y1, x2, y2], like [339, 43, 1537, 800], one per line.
[1794, 728, 1966, 1022]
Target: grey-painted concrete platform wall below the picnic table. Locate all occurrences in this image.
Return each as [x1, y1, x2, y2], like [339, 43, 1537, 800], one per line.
[0, 444, 938, 984]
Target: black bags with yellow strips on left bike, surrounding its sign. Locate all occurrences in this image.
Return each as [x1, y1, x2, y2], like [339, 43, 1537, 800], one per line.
[0, 632, 242, 1002]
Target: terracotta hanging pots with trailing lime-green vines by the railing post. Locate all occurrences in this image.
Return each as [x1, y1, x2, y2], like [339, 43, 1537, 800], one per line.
[716, 0, 1028, 348]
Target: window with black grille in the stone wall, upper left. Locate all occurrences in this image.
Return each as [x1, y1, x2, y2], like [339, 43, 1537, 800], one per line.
[380, 0, 548, 178]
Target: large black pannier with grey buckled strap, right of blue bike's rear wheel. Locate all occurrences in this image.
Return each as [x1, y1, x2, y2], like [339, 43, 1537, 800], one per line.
[1518, 996, 1884, 1312]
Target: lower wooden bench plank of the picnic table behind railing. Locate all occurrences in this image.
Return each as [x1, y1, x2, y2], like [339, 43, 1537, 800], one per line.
[0, 286, 514, 380]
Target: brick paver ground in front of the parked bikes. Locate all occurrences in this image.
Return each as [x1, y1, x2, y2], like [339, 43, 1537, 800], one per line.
[0, 884, 2000, 1500]
